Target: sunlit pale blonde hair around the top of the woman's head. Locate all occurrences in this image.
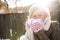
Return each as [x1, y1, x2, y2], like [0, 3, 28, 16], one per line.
[28, 5, 51, 19]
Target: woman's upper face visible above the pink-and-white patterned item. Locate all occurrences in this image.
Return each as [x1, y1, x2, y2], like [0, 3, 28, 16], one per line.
[32, 10, 45, 21]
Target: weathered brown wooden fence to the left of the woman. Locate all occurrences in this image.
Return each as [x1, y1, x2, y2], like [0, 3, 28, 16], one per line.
[0, 13, 27, 40]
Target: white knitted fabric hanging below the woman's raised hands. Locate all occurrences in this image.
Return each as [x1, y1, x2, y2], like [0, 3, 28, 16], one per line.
[20, 28, 34, 40]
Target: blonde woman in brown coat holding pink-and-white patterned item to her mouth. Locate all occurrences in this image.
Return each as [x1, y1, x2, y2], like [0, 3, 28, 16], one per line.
[21, 5, 58, 40]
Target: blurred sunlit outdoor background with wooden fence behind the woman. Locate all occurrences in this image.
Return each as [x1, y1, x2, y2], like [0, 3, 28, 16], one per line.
[0, 0, 60, 40]
